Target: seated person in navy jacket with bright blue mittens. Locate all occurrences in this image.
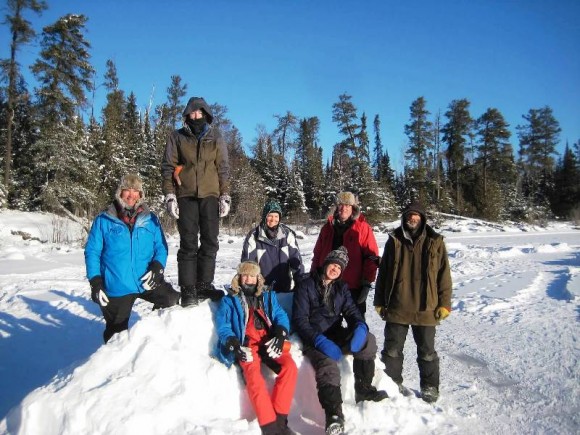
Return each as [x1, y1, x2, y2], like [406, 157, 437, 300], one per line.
[292, 246, 388, 434]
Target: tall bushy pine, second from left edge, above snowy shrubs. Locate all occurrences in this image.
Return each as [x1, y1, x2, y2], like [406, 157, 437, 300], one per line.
[31, 14, 94, 213]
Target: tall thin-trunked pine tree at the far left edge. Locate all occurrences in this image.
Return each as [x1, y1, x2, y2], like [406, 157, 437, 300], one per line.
[0, 0, 48, 192]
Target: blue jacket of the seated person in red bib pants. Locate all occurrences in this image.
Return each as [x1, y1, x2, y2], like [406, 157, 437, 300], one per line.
[215, 275, 290, 367]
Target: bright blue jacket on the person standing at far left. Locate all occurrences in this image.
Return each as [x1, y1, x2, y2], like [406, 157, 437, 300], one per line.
[85, 204, 167, 297]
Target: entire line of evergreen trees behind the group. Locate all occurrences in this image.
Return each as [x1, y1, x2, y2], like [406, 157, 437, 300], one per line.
[0, 0, 580, 230]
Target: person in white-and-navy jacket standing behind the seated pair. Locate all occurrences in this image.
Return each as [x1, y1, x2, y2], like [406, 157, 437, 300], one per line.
[241, 199, 304, 293]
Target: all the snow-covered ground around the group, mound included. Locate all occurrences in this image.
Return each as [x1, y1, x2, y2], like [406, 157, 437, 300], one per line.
[0, 211, 580, 435]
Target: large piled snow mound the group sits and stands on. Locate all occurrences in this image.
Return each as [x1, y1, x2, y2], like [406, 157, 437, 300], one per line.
[0, 302, 444, 435]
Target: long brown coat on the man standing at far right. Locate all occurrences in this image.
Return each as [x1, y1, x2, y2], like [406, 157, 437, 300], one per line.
[374, 221, 452, 326]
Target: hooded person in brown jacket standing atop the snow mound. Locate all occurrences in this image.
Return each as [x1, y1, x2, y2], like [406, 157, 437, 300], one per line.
[161, 97, 231, 307]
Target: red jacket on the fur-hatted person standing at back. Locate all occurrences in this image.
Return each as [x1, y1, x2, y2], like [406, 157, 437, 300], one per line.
[310, 214, 379, 289]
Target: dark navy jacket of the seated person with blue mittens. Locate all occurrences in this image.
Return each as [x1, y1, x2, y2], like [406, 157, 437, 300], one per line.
[292, 272, 365, 346]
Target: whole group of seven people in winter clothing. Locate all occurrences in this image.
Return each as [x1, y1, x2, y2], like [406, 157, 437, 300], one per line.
[85, 97, 452, 434]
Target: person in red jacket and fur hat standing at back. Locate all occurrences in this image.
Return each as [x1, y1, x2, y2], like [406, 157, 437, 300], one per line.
[310, 192, 379, 317]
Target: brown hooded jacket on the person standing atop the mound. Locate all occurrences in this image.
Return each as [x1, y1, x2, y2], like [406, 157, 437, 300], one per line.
[161, 97, 229, 198]
